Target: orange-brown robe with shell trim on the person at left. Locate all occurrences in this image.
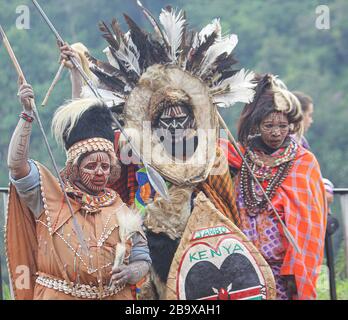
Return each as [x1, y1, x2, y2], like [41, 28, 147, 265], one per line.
[6, 164, 133, 300]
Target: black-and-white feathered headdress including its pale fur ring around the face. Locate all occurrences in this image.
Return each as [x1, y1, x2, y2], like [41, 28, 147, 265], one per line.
[83, 1, 255, 185]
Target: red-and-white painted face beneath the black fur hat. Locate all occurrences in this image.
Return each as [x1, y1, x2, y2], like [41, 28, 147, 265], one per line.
[79, 152, 110, 193]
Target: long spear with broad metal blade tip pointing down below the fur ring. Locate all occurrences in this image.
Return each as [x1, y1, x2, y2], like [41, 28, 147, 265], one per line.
[32, 0, 169, 201]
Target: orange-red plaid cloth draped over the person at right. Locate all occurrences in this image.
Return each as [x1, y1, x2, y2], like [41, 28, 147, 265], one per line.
[220, 140, 327, 300]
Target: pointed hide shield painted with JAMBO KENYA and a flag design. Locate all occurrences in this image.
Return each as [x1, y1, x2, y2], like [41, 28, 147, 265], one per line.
[166, 193, 276, 300]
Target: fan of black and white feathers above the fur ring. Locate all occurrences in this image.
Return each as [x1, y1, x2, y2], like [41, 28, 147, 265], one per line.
[84, 1, 255, 107]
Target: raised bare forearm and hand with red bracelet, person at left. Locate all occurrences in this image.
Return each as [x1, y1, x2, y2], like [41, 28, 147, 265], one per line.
[7, 79, 34, 180]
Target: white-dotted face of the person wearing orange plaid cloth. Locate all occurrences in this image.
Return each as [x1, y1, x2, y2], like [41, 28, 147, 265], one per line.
[260, 112, 289, 149]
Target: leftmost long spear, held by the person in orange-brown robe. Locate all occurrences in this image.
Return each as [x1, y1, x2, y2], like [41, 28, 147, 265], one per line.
[0, 25, 88, 253]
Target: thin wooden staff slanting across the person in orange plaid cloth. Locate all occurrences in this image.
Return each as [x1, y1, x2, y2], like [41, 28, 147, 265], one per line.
[217, 112, 301, 253]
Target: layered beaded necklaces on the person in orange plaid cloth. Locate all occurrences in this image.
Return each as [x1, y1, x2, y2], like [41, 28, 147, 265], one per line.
[240, 141, 298, 215]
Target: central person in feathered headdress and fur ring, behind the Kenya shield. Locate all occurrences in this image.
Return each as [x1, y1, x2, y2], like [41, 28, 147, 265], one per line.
[55, 1, 278, 299]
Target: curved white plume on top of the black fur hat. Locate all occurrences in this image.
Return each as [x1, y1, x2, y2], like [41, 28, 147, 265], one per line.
[52, 98, 103, 147]
